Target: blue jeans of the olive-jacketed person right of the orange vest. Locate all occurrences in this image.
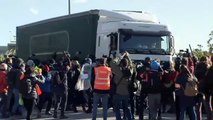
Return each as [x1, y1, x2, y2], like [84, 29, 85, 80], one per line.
[113, 95, 132, 120]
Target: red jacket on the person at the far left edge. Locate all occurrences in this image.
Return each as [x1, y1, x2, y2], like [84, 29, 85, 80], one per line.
[0, 71, 8, 93]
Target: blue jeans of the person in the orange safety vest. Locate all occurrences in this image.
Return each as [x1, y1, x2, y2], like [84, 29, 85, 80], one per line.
[92, 93, 109, 120]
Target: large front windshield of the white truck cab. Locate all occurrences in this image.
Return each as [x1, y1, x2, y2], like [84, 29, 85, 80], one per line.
[119, 33, 171, 55]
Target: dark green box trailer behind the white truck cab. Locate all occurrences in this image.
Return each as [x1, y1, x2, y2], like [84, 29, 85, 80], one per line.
[16, 10, 99, 60]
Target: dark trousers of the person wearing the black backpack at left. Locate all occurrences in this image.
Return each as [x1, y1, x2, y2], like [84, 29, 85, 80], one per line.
[22, 97, 35, 120]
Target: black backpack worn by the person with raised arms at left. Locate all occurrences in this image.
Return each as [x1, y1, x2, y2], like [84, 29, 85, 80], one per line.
[19, 78, 33, 95]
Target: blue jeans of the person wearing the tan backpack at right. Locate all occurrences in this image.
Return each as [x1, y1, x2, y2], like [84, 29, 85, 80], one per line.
[179, 105, 197, 120]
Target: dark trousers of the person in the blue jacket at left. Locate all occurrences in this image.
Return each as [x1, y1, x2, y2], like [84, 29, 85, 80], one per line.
[38, 92, 53, 113]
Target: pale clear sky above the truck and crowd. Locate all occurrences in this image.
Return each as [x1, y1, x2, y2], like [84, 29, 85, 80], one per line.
[0, 0, 213, 49]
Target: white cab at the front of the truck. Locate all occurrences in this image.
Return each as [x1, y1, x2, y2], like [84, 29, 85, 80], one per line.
[96, 10, 174, 61]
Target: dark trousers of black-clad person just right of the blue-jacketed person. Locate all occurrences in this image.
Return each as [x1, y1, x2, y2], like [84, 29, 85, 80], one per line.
[54, 94, 67, 116]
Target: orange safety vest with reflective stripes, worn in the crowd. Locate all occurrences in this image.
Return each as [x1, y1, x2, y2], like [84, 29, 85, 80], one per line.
[94, 66, 112, 90]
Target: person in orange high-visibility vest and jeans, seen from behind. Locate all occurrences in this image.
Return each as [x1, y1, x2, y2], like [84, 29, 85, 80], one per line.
[92, 58, 112, 120]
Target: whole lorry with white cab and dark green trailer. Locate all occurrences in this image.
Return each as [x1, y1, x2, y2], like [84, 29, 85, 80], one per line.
[17, 10, 174, 62]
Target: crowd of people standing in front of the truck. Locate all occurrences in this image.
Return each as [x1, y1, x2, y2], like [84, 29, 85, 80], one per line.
[0, 52, 213, 120]
